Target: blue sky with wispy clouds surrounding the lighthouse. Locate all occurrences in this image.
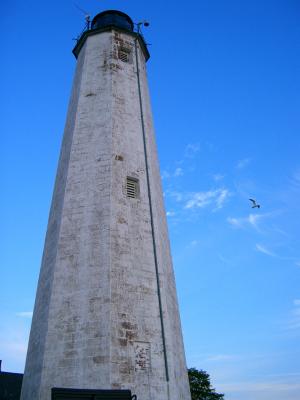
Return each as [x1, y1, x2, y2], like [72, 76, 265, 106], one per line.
[0, 0, 300, 400]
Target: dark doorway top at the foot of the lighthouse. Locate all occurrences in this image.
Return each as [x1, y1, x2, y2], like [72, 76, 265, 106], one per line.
[51, 388, 136, 400]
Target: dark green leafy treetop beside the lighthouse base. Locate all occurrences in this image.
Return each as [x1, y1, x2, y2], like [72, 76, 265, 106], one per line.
[188, 368, 224, 400]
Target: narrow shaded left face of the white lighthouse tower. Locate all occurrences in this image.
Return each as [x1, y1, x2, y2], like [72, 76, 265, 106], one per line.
[21, 37, 85, 399]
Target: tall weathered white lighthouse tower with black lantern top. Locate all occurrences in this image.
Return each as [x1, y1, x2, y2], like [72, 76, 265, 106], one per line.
[21, 10, 190, 400]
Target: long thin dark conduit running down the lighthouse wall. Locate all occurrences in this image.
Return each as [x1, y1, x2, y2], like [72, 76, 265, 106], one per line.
[134, 33, 169, 382]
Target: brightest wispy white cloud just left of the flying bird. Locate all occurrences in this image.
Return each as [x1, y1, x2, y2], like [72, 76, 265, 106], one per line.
[184, 189, 230, 209]
